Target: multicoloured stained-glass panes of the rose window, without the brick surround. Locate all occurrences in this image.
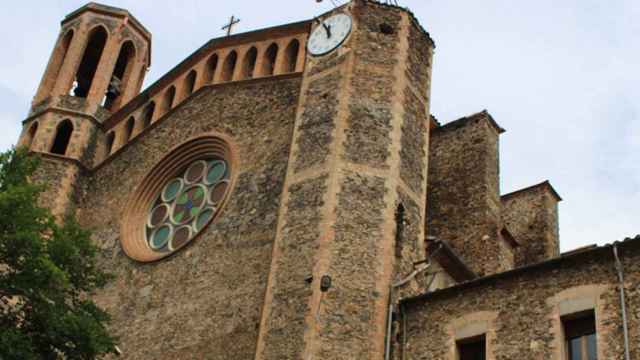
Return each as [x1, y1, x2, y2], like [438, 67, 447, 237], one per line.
[144, 158, 230, 253]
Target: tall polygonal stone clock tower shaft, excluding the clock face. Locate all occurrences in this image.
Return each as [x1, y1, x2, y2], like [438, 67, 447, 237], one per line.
[256, 1, 432, 359]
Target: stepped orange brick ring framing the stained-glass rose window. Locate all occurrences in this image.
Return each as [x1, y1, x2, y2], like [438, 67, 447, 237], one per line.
[120, 133, 239, 262]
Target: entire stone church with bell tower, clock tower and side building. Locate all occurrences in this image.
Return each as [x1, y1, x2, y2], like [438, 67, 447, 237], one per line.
[19, 0, 640, 360]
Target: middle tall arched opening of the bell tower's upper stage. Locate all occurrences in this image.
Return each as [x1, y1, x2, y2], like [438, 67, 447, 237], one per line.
[71, 26, 107, 98]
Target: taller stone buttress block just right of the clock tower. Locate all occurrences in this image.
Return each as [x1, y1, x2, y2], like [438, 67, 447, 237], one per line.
[427, 112, 510, 275]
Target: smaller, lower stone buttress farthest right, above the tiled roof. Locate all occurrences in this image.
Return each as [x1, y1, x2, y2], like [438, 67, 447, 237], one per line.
[502, 182, 561, 266]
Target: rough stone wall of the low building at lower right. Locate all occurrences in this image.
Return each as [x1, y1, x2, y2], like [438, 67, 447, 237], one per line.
[395, 237, 640, 360]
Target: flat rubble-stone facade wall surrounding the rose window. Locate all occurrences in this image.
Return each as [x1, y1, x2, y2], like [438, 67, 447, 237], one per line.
[78, 76, 300, 359]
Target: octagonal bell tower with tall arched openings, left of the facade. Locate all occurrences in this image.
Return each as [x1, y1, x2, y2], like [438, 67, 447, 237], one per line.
[18, 3, 151, 215]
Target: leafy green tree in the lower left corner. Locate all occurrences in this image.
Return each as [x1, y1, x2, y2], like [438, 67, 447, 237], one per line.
[0, 150, 115, 360]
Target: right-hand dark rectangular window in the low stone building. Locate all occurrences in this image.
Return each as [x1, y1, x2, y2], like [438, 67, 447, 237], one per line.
[562, 310, 598, 360]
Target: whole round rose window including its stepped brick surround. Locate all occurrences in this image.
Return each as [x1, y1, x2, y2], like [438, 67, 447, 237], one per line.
[122, 137, 233, 262]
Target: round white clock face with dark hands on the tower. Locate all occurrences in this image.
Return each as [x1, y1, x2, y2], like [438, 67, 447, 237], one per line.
[307, 14, 352, 56]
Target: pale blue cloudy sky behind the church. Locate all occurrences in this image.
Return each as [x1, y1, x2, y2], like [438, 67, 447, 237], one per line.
[0, 0, 640, 250]
